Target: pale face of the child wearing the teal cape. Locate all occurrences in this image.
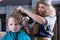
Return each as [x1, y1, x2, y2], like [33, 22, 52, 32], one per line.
[8, 17, 22, 32]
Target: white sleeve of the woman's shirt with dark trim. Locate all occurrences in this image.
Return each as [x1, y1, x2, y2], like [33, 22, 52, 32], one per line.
[45, 15, 56, 31]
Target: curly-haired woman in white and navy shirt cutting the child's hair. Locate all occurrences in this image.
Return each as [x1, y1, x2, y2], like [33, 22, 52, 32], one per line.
[16, 2, 56, 40]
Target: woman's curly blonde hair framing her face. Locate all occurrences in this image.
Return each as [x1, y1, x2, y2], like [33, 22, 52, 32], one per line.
[33, 2, 56, 17]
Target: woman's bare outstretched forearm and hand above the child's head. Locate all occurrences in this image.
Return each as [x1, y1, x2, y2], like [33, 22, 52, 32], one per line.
[17, 6, 46, 24]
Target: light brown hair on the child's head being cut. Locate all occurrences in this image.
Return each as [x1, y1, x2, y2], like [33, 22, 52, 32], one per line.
[8, 9, 24, 25]
